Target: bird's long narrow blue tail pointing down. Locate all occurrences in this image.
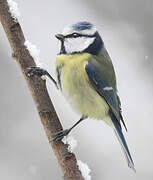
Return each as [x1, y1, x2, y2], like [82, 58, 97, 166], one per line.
[111, 112, 136, 172]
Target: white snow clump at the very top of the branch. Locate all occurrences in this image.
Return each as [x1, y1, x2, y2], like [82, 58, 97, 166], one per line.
[7, 0, 20, 19]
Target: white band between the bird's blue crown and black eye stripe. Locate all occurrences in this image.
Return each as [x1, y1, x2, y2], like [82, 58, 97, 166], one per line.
[62, 26, 97, 35]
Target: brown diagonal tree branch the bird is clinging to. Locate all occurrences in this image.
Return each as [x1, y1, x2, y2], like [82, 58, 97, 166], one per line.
[0, 0, 84, 180]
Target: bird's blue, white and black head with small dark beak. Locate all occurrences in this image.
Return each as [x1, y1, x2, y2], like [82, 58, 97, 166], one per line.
[55, 21, 103, 55]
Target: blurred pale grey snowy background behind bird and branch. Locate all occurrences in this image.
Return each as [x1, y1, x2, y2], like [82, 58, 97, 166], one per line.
[0, 0, 153, 180]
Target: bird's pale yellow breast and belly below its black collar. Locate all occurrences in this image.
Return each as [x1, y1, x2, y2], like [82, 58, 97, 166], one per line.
[56, 53, 109, 123]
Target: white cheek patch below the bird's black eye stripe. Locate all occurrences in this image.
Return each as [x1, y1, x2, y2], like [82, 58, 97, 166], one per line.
[64, 37, 95, 53]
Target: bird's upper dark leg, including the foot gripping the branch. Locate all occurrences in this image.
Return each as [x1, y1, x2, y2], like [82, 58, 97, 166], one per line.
[26, 67, 59, 89]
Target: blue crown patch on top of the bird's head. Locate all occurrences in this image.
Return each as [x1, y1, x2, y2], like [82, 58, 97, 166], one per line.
[72, 21, 93, 31]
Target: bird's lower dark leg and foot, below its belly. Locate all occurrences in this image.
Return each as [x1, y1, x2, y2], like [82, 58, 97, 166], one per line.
[51, 115, 87, 141]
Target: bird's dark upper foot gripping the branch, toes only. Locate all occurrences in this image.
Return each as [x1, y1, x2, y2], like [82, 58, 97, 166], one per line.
[26, 67, 46, 77]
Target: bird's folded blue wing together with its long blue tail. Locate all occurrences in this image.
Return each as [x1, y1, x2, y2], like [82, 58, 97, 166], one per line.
[85, 61, 135, 171]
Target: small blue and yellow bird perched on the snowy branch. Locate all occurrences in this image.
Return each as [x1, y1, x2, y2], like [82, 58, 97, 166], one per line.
[28, 21, 135, 171]
